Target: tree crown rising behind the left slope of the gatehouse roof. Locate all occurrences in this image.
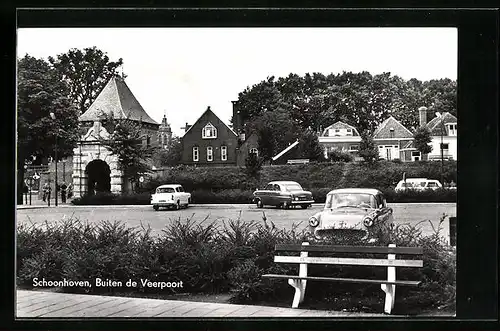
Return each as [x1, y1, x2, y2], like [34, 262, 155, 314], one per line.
[49, 46, 123, 114]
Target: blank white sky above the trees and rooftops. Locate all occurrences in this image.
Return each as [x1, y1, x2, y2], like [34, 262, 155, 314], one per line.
[17, 28, 458, 136]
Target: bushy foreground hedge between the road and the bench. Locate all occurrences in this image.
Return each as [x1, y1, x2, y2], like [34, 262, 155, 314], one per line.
[17, 219, 456, 314]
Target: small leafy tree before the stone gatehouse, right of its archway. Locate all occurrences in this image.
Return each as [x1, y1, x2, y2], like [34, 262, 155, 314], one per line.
[101, 119, 157, 187]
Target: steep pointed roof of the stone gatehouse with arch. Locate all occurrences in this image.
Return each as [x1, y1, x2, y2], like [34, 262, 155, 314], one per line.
[78, 76, 158, 125]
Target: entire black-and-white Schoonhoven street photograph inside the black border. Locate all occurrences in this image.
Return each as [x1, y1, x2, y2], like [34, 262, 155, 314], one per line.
[14, 27, 460, 320]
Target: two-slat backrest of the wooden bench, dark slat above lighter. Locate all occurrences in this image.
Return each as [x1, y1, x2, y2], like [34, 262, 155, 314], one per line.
[274, 244, 423, 268]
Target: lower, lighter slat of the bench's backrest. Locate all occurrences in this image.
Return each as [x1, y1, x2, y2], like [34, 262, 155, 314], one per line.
[274, 256, 423, 267]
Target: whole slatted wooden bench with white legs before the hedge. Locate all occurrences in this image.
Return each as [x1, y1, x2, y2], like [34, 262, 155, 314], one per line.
[262, 242, 423, 314]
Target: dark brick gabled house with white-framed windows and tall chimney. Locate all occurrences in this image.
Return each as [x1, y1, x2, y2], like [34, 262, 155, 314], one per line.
[181, 102, 258, 166]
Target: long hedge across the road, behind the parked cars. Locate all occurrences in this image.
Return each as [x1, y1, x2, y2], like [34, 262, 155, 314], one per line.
[146, 161, 457, 192]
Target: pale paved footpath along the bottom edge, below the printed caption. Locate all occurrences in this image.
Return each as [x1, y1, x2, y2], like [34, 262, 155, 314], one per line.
[16, 290, 382, 319]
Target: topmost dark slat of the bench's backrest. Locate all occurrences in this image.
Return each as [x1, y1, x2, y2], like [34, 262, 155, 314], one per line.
[275, 244, 423, 255]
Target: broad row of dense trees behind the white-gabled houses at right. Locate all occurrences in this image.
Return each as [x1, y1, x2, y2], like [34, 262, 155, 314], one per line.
[232, 71, 457, 159]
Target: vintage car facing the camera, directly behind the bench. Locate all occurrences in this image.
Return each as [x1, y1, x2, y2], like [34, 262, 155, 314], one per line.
[309, 188, 394, 241]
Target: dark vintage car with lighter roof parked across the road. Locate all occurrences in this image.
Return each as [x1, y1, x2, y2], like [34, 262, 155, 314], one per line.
[253, 181, 314, 209]
